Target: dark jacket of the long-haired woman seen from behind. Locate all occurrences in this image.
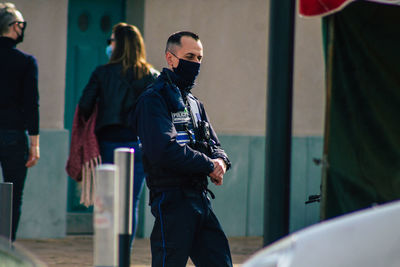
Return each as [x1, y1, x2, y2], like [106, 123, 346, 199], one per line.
[79, 64, 158, 138]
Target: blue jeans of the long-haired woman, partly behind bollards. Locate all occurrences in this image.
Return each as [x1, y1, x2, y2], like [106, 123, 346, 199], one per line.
[99, 140, 145, 247]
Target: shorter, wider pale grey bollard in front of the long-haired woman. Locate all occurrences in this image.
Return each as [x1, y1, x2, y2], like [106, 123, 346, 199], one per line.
[93, 164, 119, 267]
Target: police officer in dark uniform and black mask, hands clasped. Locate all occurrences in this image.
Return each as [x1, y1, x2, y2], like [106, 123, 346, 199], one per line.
[133, 32, 232, 267]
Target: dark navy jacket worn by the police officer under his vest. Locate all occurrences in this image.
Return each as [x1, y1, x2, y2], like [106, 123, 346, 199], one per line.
[132, 69, 228, 188]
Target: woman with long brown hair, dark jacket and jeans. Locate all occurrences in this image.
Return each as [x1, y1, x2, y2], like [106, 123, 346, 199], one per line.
[79, 23, 158, 247]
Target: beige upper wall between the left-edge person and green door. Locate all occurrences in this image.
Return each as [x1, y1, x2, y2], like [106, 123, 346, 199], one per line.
[11, 0, 68, 129]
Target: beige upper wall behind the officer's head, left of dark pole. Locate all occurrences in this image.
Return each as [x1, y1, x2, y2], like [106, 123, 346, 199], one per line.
[144, 0, 268, 135]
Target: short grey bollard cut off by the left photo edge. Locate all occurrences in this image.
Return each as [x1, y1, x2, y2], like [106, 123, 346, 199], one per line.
[0, 183, 13, 245]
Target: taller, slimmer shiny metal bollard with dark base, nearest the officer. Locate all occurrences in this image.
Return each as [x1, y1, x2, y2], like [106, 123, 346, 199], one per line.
[114, 147, 135, 267]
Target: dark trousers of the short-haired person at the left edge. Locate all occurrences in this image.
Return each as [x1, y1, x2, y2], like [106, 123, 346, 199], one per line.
[0, 129, 29, 241]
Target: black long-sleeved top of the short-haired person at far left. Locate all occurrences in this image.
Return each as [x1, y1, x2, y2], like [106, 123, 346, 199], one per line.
[0, 37, 39, 135]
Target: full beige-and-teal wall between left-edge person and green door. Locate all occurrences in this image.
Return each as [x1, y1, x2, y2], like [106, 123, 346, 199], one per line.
[0, 0, 69, 238]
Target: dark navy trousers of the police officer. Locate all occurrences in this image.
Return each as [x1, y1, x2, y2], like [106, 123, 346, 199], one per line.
[150, 188, 232, 267]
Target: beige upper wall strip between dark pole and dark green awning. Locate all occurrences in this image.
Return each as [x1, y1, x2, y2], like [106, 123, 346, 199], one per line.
[293, 15, 325, 136]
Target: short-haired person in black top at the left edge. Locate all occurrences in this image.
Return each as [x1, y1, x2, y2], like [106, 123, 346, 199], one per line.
[0, 3, 40, 241]
